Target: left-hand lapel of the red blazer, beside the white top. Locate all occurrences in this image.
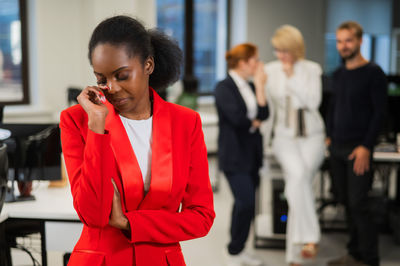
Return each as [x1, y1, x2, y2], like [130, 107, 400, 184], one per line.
[105, 102, 144, 211]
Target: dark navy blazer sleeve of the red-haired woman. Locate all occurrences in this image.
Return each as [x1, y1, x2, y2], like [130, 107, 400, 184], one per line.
[215, 82, 251, 129]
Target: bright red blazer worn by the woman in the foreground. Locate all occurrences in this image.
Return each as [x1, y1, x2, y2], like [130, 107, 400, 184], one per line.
[60, 89, 215, 266]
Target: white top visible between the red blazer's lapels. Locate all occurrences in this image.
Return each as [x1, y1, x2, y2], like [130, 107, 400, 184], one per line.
[120, 115, 153, 192]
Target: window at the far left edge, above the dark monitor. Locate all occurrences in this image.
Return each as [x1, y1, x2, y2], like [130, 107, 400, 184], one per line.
[0, 0, 28, 105]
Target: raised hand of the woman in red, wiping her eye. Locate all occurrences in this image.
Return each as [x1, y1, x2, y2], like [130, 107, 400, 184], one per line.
[77, 86, 108, 134]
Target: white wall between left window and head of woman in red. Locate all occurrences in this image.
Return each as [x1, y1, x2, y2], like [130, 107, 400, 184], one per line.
[4, 0, 156, 122]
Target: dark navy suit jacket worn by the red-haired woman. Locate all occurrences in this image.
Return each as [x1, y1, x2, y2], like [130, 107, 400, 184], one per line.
[215, 76, 269, 173]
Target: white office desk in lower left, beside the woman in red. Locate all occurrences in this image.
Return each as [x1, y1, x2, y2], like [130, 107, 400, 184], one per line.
[0, 181, 82, 266]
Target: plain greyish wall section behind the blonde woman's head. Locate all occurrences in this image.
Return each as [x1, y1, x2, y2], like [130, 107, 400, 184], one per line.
[246, 0, 325, 65]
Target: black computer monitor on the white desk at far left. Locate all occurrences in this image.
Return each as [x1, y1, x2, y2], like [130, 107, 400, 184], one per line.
[0, 123, 61, 201]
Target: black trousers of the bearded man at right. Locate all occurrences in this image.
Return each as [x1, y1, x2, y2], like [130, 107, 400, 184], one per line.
[330, 143, 379, 266]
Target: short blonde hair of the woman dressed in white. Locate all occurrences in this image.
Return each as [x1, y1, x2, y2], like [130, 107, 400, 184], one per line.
[271, 25, 305, 59]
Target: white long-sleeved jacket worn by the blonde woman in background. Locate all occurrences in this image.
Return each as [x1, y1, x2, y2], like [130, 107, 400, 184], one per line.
[265, 59, 324, 137]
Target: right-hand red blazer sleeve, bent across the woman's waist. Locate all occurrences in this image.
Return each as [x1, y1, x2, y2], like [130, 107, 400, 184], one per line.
[126, 114, 215, 243]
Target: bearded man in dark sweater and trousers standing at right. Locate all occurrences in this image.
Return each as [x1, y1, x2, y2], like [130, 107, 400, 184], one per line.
[327, 21, 387, 266]
